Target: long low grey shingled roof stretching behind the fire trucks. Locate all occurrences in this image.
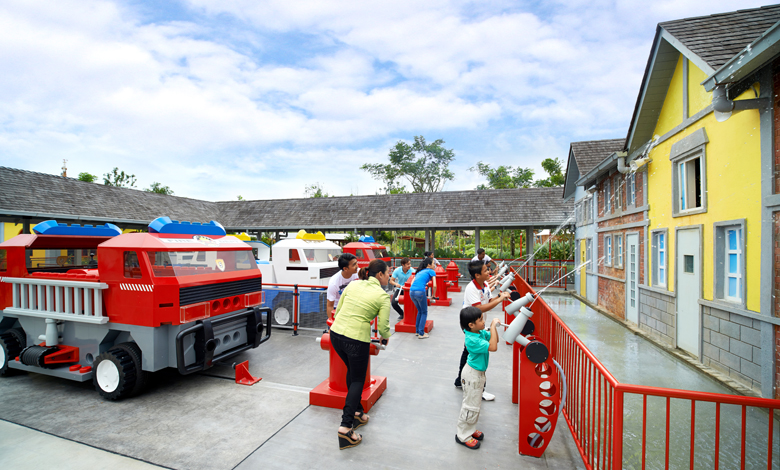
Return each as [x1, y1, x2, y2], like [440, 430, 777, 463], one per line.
[0, 167, 573, 231]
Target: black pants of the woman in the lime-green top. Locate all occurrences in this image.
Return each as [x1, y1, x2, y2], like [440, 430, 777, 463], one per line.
[330, 331, 371, 428]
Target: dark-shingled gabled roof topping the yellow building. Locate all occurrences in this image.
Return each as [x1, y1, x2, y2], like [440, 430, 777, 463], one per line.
[626, 5, 780, 157]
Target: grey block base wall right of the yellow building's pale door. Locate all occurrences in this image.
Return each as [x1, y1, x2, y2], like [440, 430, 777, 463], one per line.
[702, 306, 761, 393]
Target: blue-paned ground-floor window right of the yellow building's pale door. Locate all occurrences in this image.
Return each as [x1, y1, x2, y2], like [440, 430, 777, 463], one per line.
[714, 219, 746, 305]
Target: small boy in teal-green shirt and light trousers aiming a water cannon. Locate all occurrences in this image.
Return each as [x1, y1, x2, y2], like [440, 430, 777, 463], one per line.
[455, 306, 499, 449]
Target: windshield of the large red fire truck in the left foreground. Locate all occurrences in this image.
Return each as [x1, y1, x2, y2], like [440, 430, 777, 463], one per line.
[147, 250, 257, 277]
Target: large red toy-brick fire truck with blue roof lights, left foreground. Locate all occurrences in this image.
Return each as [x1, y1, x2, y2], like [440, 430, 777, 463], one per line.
[0, 217, 271, 400]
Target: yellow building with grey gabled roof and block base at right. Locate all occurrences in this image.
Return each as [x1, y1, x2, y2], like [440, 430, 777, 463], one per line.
[625, 6, 780, 397]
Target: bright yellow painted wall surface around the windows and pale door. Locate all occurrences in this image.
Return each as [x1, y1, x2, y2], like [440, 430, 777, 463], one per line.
[647, 59, 761, 312]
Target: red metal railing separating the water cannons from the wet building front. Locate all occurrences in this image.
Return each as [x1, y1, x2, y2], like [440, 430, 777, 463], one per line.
[513, 276, 780, 469]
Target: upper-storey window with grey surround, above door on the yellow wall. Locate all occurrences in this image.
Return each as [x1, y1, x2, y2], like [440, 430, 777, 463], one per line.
[669, 128, 709, 217]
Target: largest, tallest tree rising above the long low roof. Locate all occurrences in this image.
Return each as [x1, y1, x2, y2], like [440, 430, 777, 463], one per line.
[360, 136, 455, 194]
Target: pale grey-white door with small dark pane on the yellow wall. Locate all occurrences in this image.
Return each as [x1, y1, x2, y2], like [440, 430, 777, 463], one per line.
[675, 229, 701, 357]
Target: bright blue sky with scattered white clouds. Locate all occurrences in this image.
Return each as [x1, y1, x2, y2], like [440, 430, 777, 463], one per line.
[0, 0, 762, 201]
